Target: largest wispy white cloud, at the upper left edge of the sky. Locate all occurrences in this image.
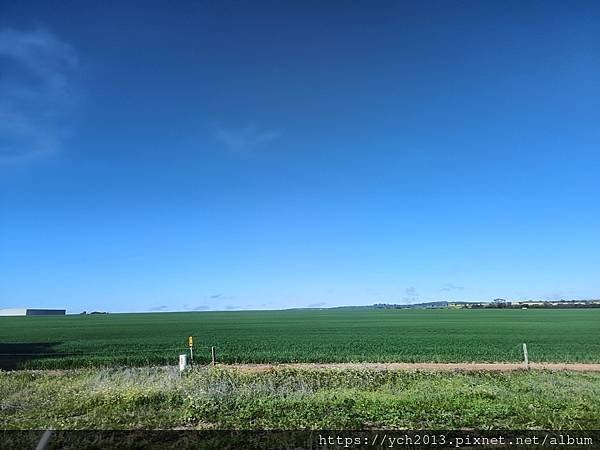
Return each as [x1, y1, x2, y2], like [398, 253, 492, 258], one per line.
[0, 28, 79, 164]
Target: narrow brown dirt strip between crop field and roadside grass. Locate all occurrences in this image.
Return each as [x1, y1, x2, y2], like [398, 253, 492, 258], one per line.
[218, 363, 600, 372]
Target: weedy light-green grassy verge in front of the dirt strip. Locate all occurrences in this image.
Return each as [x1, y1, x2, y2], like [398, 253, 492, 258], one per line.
[0, 368, 600, 429]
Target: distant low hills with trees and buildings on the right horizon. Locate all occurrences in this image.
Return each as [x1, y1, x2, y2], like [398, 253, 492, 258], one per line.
[373, 298, 600, 309]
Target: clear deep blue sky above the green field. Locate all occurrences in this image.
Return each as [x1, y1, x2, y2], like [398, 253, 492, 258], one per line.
[0, 0, 600, 312]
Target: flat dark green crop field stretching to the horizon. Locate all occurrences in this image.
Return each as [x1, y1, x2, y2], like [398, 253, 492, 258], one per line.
[0, 309, 600, 369]
